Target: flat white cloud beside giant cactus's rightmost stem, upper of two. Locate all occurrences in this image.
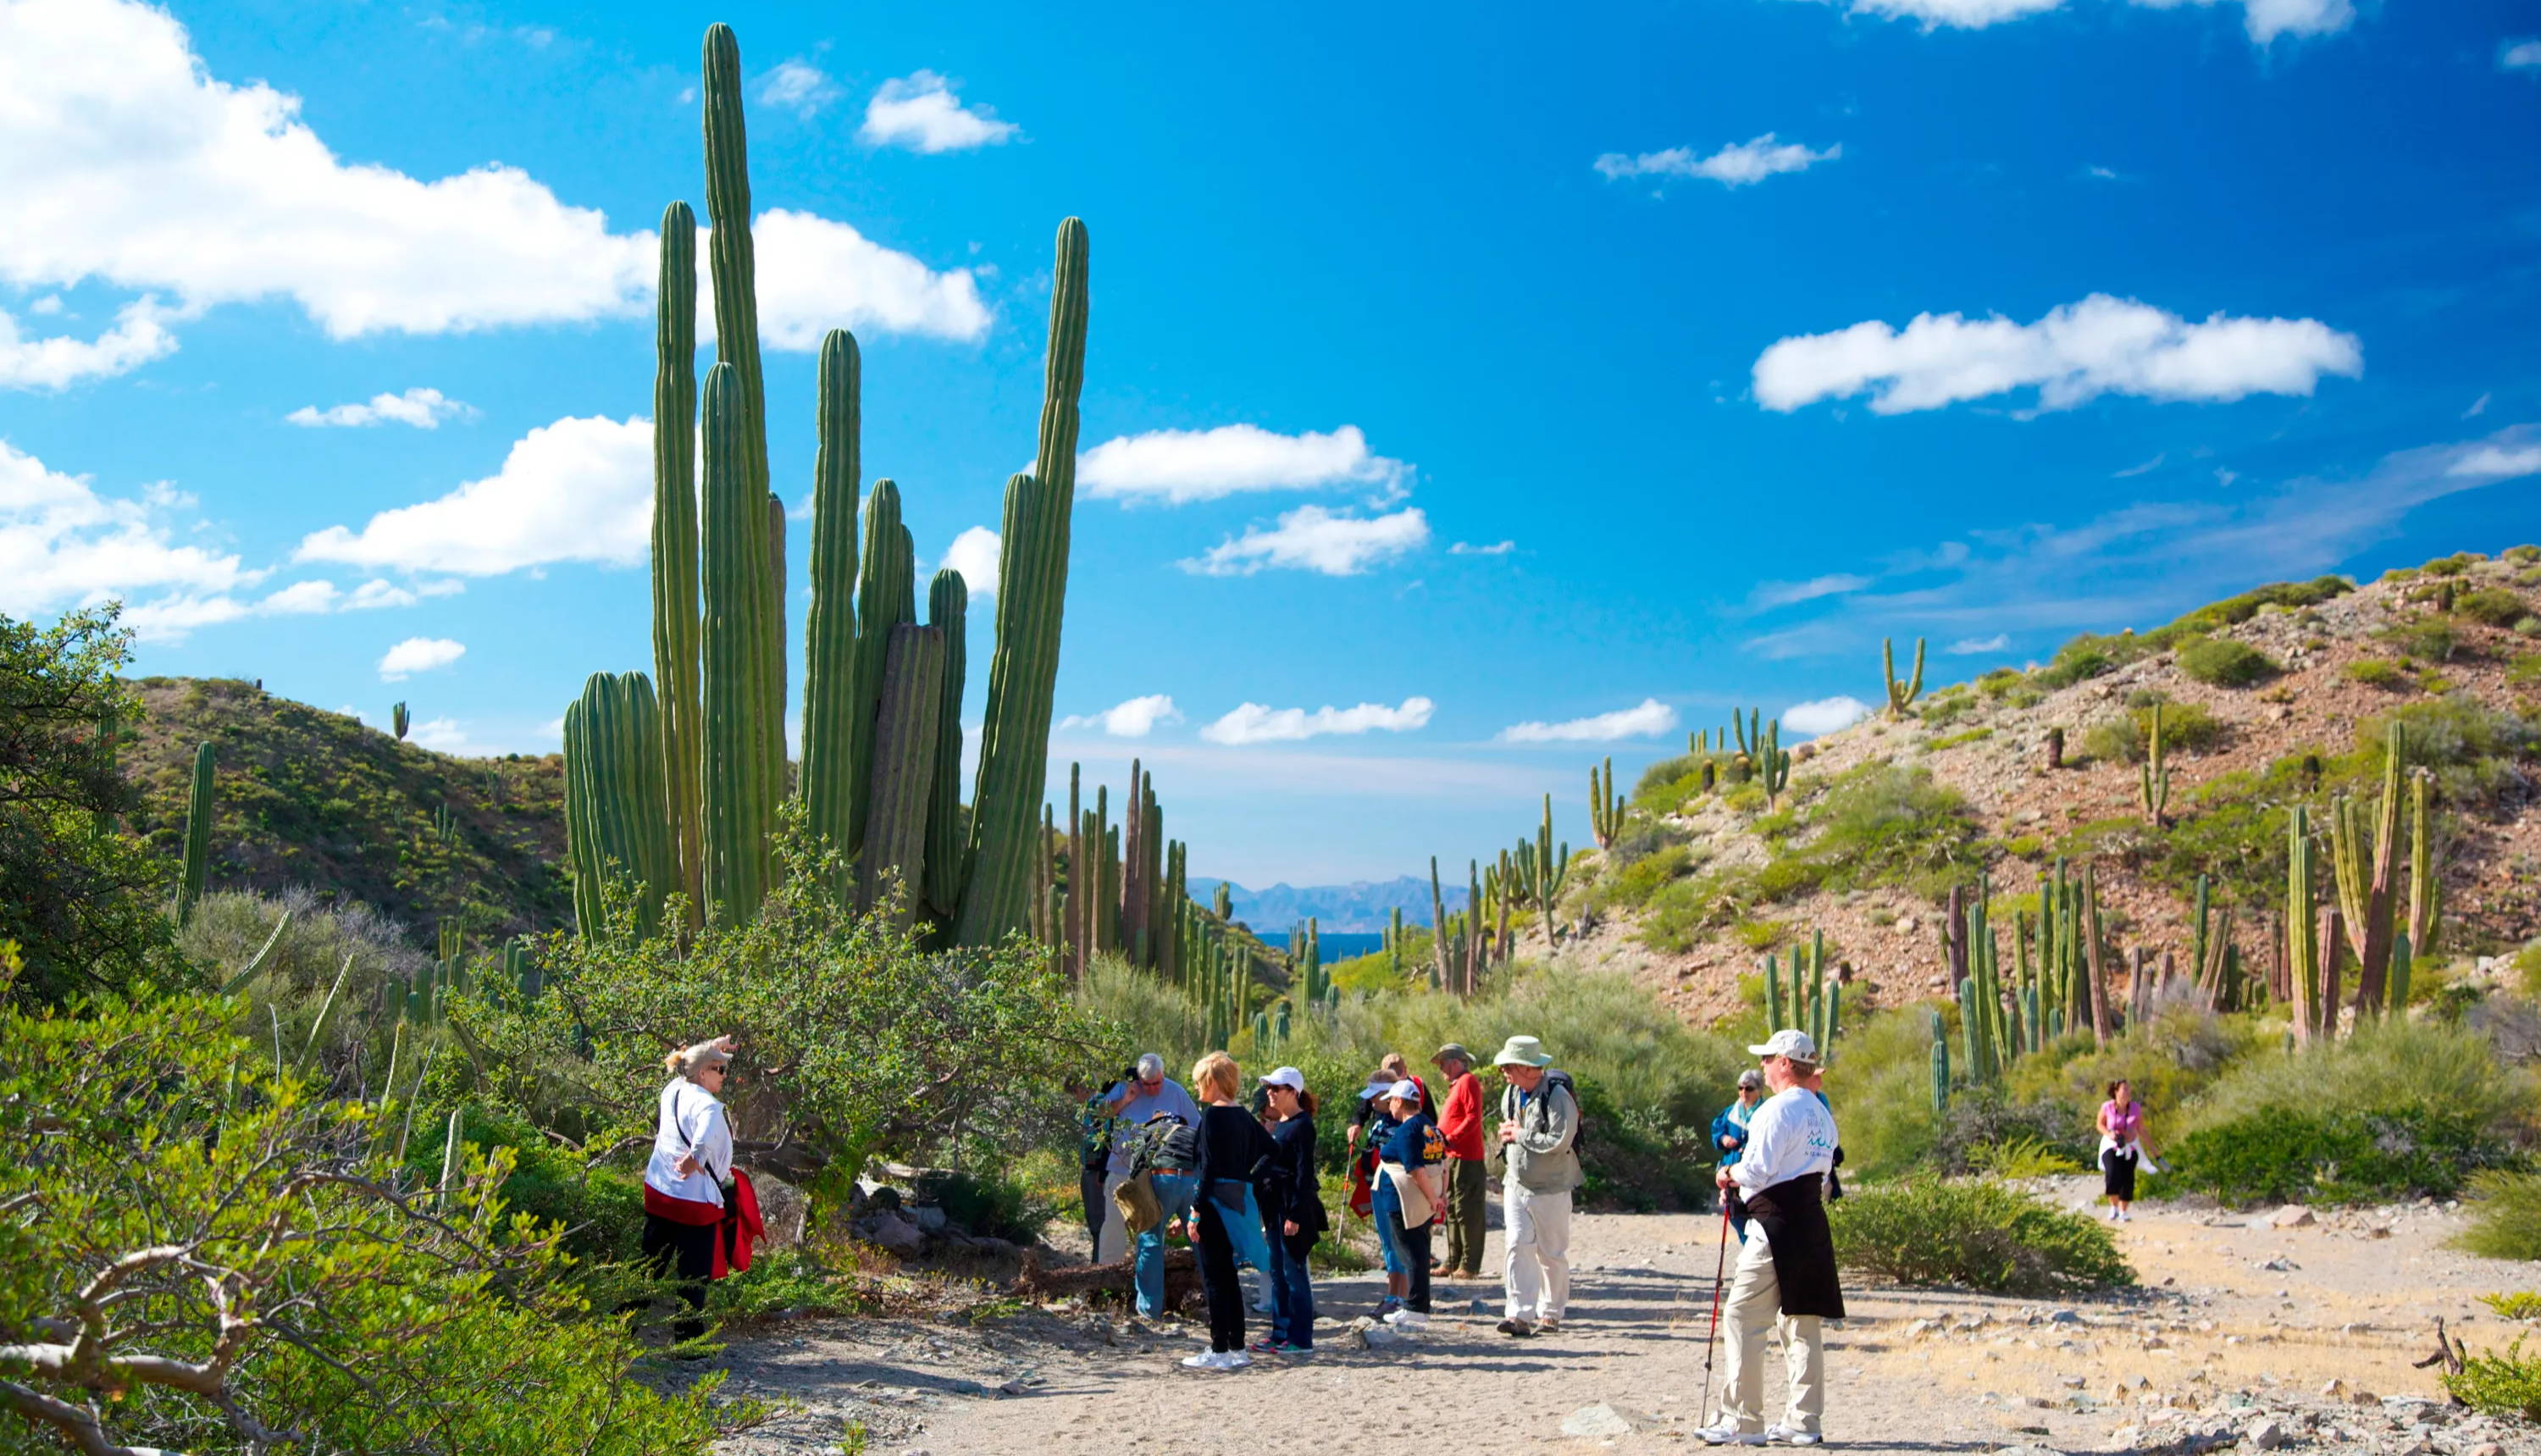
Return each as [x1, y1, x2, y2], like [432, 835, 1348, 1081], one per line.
[1077, 424, 1410, 506]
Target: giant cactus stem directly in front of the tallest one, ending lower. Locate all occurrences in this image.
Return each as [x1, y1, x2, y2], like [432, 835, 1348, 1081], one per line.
[701, 363, 783, 922]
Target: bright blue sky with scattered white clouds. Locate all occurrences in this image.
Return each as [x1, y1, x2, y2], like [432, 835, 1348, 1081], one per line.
[0, 0, 2541, 884]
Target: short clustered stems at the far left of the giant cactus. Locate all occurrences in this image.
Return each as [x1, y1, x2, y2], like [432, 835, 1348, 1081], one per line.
[562, 673, 676, 935]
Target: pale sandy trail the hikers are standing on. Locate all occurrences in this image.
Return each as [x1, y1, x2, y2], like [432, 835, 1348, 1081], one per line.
[727, 1207, 2541, 1456]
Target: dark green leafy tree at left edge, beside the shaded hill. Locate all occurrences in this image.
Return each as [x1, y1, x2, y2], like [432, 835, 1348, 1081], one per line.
[0, 605, 185, 1004]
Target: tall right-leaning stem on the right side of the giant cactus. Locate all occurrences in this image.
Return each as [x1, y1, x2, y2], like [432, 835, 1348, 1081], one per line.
[960, 219, 1088, 945]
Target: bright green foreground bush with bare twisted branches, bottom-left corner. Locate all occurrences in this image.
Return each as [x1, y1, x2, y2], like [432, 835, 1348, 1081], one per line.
[0, 981, 755, 1456]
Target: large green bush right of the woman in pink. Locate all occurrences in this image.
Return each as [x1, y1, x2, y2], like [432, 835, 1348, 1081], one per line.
[2170, 1021, 2536, 1204]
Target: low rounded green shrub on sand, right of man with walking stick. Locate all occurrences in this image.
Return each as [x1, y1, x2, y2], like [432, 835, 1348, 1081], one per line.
[1830, 1179, 2134, 1296]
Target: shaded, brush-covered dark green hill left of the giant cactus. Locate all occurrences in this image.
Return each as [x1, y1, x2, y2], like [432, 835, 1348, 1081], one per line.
[122, 678, 572, 945]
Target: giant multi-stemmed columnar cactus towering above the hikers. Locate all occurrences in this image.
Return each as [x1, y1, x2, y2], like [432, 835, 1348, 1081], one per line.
[567, 25, 1088, 945]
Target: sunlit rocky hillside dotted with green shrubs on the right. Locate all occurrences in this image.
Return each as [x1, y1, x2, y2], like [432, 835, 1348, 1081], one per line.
[1563, 546, 2541, 1021]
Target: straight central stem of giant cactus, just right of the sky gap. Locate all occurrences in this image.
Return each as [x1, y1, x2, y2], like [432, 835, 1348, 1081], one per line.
[800, 328, 882, 879]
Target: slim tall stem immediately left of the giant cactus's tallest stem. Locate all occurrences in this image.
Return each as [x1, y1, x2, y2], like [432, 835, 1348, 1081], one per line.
[653, 203, 706, 927]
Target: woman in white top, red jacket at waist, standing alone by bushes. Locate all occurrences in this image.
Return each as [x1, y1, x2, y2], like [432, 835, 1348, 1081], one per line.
[643, 1037, 762, 1342]
